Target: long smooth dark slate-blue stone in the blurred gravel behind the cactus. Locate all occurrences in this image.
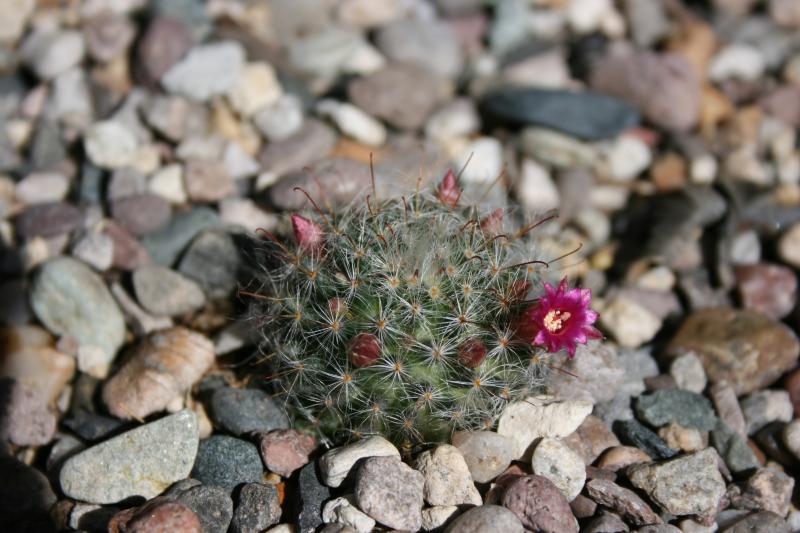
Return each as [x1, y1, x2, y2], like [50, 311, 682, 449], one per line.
[482, 88, 639, 140]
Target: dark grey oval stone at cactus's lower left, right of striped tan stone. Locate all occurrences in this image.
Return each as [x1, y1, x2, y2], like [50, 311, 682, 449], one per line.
[209, 387, 289, 436]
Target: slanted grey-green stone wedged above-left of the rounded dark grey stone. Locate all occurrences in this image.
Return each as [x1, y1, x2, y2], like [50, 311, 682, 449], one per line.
[142, 207, 220, 266]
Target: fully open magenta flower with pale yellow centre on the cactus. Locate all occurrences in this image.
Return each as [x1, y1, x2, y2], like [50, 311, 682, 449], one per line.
[517, 277, 603, 358]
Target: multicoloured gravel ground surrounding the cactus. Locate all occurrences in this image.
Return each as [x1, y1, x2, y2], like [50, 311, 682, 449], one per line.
[0, 0, 800, 533]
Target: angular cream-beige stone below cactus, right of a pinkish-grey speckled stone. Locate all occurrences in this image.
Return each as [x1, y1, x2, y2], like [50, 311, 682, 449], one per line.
[414, 444, 483, 505]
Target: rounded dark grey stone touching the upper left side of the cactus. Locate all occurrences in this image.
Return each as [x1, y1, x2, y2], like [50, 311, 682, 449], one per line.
[178, 230, 242, 300]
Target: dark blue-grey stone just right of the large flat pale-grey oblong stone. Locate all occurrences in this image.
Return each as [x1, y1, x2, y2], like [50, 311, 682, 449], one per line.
[192, 435, 264, 493]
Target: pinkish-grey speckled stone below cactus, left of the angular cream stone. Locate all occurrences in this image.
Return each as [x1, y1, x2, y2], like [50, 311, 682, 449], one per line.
[354, 454, 425, 531]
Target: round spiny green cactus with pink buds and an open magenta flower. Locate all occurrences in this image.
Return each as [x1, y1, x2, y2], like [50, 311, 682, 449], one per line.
[247, 171, 597, 445]
